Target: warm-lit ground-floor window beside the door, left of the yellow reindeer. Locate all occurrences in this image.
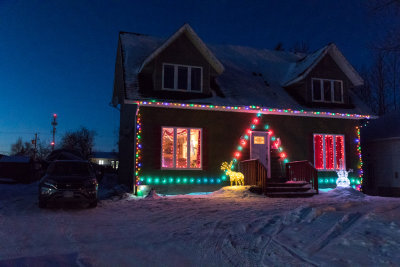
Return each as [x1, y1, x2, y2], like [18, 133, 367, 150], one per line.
[161, 127, 202, 169]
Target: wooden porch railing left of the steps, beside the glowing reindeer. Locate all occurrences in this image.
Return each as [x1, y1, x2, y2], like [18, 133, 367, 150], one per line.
[239, 159, 268, 191]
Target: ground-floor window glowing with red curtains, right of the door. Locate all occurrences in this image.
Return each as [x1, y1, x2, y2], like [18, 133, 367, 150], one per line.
[314, 134, 346, 171]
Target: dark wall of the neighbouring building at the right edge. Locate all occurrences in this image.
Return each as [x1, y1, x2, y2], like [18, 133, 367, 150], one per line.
[363, 138, 400, 196]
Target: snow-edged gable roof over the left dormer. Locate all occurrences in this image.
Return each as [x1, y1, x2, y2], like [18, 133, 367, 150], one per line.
[138, 24, 224, 74]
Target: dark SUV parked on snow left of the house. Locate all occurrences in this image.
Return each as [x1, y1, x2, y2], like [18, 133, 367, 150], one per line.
[39, 160, 98, 208]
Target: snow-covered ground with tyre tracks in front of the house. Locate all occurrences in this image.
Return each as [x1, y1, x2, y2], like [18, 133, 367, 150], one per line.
[0, 181, 400, 266]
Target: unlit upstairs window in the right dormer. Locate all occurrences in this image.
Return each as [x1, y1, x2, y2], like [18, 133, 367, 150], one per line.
[312, 78, 343, 103]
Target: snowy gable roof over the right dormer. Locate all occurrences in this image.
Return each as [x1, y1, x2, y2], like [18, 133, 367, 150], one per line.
[284, 43, 364, 86]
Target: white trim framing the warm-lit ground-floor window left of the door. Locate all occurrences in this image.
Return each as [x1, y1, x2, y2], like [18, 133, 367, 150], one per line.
[160, 126, 203, 171]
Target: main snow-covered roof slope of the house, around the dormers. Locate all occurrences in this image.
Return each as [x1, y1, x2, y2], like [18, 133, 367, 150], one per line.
[120, 27, 371, 115]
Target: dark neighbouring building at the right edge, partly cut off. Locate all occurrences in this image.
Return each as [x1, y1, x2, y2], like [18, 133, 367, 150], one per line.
[362, 111, 400, 196]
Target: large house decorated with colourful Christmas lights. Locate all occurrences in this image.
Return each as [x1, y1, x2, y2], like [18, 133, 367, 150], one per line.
[112, 24, 371, 196]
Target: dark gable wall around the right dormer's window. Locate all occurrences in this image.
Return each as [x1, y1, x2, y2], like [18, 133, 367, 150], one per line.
[287, 54, 353, 108]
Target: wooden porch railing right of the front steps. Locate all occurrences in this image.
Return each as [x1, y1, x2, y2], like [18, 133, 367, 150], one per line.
[286, 160, 318, 193]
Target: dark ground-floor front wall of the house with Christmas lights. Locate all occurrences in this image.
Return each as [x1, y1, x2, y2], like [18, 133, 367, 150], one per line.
[136, 107, 358, 195]
